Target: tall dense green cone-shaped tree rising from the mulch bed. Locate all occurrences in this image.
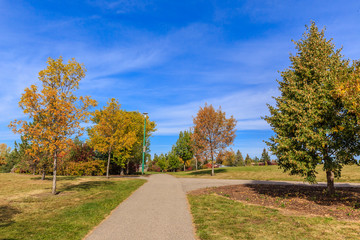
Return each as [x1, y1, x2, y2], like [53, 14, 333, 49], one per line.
[265, 22, 360, 194]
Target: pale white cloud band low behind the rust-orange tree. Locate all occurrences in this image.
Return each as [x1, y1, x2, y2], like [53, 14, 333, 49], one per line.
[149, 89, 278, 135]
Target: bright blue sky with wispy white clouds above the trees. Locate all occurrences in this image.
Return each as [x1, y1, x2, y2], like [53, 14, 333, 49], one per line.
[0, 0, 360, 157]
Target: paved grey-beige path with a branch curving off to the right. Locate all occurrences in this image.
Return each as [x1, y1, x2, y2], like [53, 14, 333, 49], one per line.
[85, 174, 360, 240]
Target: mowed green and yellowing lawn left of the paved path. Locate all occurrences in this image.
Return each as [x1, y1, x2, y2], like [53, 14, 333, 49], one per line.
[0, 173, 146, 240]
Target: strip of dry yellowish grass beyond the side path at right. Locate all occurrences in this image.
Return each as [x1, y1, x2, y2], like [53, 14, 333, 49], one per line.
[169, 165, 360, 182]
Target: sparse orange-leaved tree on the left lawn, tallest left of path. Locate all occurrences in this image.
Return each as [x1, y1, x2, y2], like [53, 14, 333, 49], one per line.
[9, 57, 97, 194]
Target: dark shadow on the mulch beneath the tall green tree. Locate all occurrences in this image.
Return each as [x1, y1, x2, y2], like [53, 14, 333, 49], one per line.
[246, 184, 360, 209]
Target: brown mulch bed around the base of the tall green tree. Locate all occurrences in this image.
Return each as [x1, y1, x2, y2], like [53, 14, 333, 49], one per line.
[190, 184, 360, 221]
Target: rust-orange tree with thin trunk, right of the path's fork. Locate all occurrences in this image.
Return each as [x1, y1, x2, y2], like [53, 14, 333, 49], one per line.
[191, 103, 236, 176]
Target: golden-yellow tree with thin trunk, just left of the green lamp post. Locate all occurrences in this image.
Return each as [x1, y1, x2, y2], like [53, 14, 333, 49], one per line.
[88, 98, 137, 178]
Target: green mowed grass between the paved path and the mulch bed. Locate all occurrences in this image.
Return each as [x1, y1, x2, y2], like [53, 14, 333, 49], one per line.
[188, 194, 360, 240]
